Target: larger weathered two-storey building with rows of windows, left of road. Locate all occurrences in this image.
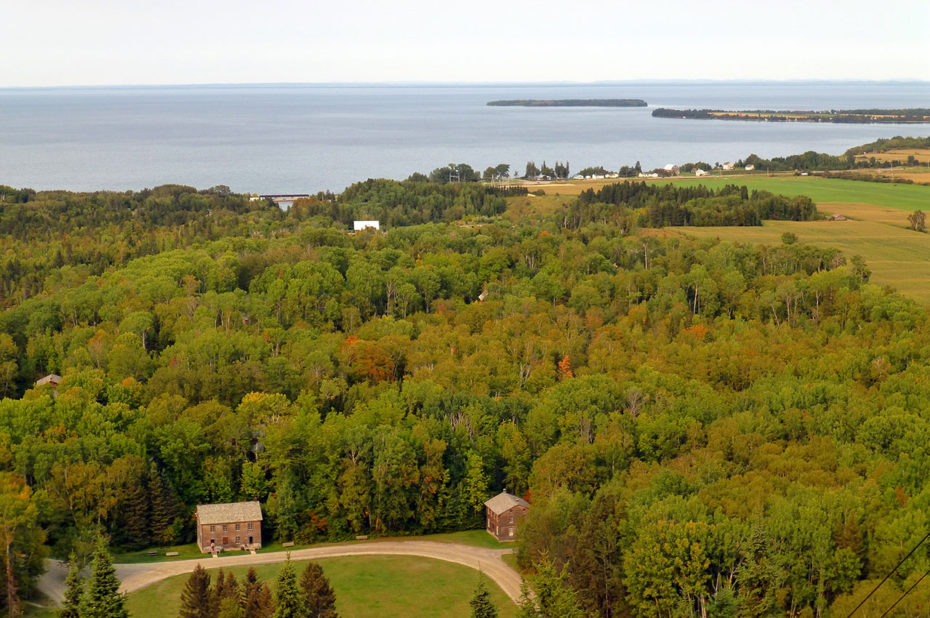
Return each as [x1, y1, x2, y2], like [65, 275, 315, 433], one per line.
[197, 501, 262, 553]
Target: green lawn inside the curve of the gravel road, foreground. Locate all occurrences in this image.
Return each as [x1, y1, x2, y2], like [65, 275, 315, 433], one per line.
[127, 556, 517, 618]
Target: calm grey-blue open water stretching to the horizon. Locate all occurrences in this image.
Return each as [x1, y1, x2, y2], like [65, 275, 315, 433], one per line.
[0, 82, 930, 193]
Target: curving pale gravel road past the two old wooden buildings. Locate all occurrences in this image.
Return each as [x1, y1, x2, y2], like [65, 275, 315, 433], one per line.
[39, 540, 522, 603]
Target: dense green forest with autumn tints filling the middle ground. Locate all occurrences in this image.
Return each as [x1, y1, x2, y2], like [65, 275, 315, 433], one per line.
[0, 176, 930, 616]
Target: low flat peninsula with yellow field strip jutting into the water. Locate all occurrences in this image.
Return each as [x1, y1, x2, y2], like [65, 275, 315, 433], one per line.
[652, 107, 930, 124]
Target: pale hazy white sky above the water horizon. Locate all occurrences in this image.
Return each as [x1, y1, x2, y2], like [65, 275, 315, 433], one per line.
[7, 0, 930, 86]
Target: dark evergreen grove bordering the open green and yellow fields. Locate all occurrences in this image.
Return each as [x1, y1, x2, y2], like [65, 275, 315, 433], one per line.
[557, 182, 819, 230]
